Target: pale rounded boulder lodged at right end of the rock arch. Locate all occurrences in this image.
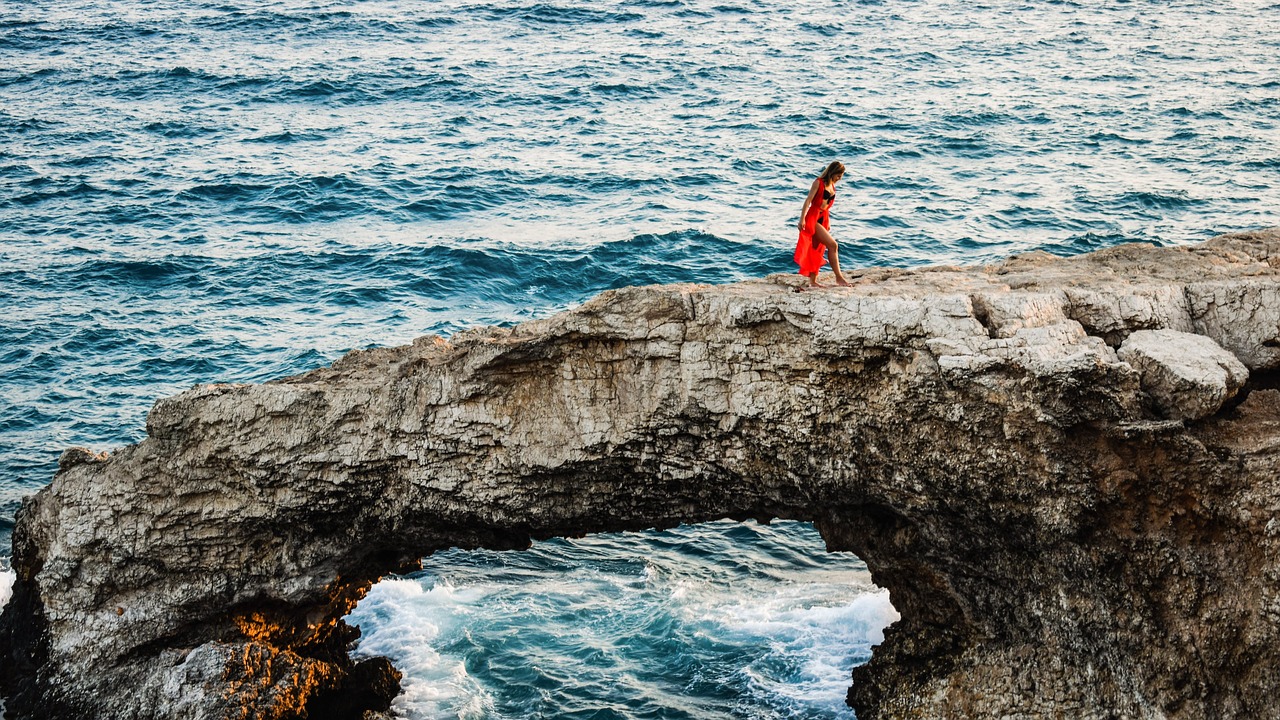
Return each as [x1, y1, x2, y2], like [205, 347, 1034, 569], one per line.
[1119, 331, 1249, 420]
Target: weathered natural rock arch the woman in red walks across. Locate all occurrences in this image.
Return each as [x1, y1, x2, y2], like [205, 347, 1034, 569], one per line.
[0, 231, 1280, 720]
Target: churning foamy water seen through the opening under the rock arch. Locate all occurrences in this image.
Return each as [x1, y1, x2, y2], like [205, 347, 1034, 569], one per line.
[352, 525, 899, 720]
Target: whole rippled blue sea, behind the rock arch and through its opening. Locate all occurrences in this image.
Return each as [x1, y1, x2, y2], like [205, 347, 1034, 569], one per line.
[0, 0, 1280, 720]
